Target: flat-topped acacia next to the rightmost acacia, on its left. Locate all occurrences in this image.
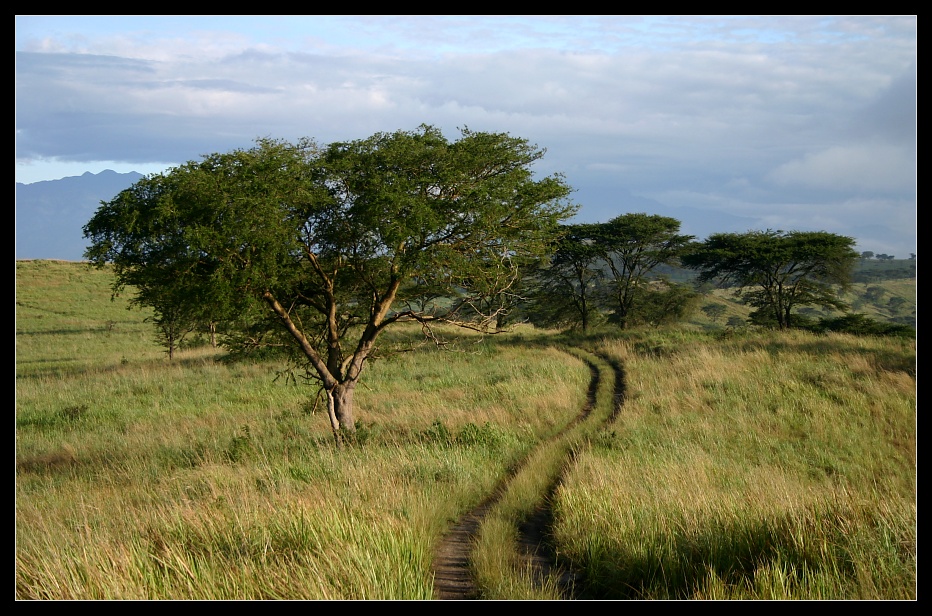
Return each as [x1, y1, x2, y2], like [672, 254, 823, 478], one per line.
[593, 213, 693, 329]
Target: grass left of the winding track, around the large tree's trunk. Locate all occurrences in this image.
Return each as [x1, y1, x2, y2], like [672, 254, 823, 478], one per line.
[16, 262, 589, 599]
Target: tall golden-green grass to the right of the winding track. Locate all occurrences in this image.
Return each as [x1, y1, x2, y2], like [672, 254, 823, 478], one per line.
[557, 331, 917, 599]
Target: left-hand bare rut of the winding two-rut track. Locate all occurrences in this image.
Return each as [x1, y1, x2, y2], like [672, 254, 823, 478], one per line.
[433, 360, 601, 600]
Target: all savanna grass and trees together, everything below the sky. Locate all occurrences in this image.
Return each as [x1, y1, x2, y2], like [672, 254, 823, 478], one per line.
[15, 126, 917, 599]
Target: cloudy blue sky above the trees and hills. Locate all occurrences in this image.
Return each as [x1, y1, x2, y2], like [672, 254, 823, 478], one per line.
[15, 15, 917, 257]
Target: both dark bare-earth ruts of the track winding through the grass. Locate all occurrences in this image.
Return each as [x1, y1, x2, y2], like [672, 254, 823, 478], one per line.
[434, 356, 623, 600]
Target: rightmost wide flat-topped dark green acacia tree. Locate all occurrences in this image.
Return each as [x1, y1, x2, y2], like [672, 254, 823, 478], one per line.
[682, 229, 860, 329]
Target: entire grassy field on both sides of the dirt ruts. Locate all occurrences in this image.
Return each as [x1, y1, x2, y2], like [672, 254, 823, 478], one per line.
[15, 261, 917, 599]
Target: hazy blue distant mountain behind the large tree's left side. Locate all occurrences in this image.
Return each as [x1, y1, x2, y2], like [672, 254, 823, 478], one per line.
[15, 170, 143, 261]
